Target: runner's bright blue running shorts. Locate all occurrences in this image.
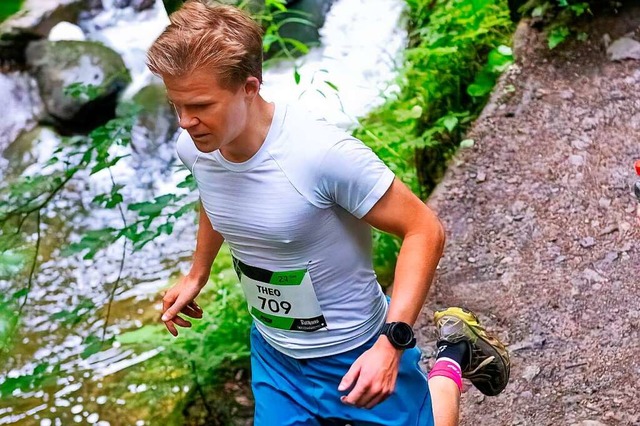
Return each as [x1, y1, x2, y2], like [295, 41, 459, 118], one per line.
[251, 327, 434, 426]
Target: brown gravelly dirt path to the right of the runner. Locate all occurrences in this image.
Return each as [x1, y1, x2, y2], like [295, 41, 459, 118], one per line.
[420, 8, 640, 426]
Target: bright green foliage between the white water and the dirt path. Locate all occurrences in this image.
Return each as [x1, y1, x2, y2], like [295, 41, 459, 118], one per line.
[354, 0, 512, 282]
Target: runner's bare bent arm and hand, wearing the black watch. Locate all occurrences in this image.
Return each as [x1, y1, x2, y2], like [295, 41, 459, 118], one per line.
[339, 178, 445, 408]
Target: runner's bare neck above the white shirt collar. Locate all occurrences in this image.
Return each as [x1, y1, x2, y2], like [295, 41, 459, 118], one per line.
[220, 95, 275, 163]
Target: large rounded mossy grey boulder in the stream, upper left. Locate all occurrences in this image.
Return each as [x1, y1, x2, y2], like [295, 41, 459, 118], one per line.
[26, 40, 131, 131]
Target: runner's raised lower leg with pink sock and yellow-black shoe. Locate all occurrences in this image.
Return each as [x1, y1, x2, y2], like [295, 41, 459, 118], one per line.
[429, 307, 511, 426]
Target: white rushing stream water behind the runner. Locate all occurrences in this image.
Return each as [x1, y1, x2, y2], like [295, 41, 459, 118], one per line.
[0, 0, 406, 425]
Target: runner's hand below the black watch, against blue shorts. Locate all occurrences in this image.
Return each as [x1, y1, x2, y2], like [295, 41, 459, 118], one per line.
[338, 336, 402, 409]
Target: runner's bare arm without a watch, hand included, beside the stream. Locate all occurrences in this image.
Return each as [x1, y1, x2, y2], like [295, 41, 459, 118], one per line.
[162, 202, 224, 336]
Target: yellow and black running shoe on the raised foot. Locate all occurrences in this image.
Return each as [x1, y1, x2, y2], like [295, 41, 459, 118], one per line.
[433, 307, 511, 396]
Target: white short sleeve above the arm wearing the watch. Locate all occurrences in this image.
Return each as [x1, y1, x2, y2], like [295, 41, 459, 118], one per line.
[318, 138, 394, 218]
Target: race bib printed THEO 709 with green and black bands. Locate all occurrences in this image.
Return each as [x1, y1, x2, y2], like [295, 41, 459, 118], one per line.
[233, 258, 327, 331]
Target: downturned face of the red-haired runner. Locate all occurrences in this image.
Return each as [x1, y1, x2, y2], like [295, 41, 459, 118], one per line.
[163, 69, 253, 152]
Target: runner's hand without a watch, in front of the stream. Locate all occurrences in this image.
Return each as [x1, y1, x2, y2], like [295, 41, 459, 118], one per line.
[162, 275, 202, 337]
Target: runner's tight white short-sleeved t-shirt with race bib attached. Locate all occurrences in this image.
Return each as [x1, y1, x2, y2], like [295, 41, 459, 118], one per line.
[177, 105, 394, 358]
